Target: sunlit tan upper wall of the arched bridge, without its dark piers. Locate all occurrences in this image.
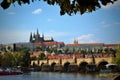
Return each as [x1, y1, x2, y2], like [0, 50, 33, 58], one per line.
[31, 57, 113, 66]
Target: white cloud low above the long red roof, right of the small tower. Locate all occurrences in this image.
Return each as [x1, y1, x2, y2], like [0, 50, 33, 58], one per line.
[76, 34, 97, 43]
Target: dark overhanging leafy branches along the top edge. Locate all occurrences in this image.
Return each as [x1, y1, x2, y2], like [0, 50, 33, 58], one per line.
[0, 0, 117, 15]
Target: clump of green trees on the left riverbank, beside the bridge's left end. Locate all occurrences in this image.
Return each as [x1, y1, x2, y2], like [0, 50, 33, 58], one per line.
[0, 48, 31, 67]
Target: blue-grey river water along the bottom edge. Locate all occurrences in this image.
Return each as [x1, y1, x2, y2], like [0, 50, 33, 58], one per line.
[0, 72, 109, 80]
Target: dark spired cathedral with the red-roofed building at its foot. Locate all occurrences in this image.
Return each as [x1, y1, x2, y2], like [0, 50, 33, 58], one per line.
[30, 29, 64, 48]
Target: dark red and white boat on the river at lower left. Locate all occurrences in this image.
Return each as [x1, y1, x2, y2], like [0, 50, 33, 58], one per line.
[0, 68, 23, 75]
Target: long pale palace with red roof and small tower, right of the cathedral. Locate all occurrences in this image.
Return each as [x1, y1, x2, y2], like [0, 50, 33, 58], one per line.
[63, 39, 120, 52]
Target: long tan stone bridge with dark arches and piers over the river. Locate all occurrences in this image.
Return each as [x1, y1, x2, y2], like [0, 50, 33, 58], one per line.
[31, 57, 113, 71]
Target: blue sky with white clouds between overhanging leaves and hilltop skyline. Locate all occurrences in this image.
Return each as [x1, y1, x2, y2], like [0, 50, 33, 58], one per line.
[0, 0, 120, 44]
